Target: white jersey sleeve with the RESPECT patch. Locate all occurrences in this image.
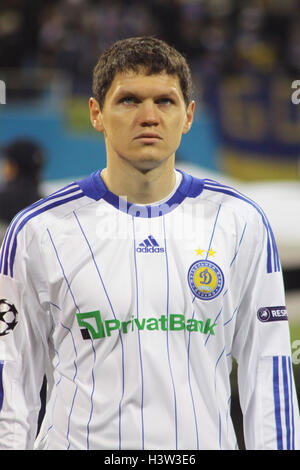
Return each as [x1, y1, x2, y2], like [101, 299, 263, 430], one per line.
[233, 211, 300, 450]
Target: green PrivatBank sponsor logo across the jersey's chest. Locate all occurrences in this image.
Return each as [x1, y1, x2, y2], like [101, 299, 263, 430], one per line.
[76, 310, 216, 339]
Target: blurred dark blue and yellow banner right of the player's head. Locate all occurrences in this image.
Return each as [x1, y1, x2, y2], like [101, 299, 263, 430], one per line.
[208, 73, 300, 180]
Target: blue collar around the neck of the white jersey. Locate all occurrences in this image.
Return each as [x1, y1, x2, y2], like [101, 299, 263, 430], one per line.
[77, 170, 204, 218]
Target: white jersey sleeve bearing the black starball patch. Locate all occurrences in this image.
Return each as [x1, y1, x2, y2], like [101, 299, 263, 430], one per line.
[0, 222, 50, 450]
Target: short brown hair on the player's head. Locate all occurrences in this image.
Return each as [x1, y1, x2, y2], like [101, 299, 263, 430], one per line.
[93, 36, 192, 109]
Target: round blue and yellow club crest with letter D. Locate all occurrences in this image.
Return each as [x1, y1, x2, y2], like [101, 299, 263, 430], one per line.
[188, 260, 224, 300]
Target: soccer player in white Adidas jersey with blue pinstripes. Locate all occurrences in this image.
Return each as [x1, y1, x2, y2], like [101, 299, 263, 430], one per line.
[0, 38, 299, 450]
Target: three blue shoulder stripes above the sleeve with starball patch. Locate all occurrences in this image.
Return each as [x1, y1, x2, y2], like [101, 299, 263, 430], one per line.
[0, 184, 84, 277]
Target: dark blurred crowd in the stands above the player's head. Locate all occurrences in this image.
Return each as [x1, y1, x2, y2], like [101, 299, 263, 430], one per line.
[0, 0, 300, 97]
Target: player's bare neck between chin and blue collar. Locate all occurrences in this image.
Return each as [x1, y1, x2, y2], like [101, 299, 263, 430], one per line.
[101, 158, 176, 204]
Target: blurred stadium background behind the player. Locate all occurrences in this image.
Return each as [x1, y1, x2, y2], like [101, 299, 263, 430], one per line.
[0, 0, 300, 446]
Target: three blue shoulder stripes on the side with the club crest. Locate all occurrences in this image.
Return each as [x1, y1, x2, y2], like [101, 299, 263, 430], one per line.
[204, 179, 280, 274]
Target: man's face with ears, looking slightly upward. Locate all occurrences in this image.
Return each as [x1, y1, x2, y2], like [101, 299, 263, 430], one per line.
[90, 71, 194, 170]
